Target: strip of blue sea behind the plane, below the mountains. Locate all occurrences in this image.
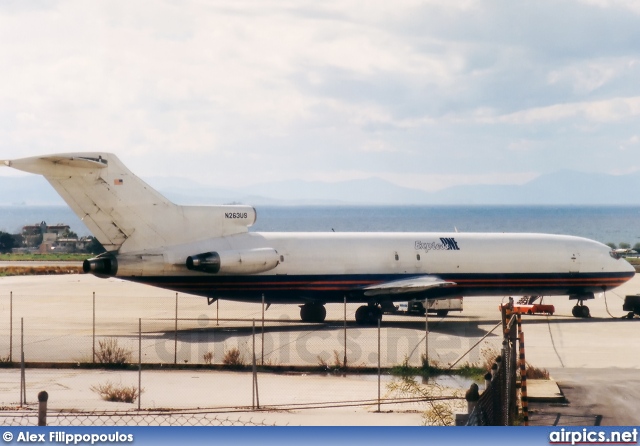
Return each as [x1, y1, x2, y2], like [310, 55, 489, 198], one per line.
[0, 205, 640, 246]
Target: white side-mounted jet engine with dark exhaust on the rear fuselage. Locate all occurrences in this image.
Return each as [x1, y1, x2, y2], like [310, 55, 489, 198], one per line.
[187, 248, 280, 274]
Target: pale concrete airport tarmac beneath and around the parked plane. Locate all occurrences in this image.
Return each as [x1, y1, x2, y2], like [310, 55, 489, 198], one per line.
[0, 275, 640, 425]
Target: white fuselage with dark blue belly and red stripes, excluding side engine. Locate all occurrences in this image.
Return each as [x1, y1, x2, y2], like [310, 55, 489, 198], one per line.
[118, 233, 635, 302]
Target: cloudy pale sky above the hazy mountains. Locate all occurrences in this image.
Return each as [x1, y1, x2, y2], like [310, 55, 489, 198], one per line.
[0, 0, 640, 191]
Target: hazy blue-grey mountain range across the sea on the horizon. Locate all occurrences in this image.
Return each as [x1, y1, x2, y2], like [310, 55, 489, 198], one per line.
[0, 171, 640, 205]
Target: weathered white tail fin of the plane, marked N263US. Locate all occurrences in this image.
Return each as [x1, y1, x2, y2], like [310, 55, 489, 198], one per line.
[4, 153, 256, 252]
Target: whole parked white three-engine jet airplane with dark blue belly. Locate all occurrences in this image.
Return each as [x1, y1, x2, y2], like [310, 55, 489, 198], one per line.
[2, 153, 635, 325]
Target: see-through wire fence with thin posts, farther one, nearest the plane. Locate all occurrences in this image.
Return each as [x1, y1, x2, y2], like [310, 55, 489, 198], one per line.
[0, 293, 496, 368]
